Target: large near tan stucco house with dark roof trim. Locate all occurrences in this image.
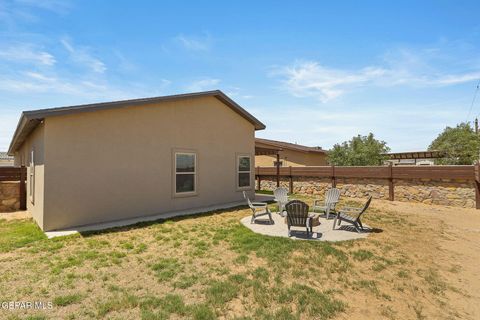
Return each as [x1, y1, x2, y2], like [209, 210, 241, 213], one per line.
[8, 90, 265, 231]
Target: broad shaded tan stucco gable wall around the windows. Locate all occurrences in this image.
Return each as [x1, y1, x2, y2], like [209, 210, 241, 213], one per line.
[44, 97, 255, 230]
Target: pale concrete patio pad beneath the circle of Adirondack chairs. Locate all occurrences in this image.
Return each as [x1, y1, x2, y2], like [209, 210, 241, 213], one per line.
[240, 213, 371, 241]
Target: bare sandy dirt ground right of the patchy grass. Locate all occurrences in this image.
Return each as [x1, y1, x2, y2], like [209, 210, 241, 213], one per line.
[364, 200, 480, 319]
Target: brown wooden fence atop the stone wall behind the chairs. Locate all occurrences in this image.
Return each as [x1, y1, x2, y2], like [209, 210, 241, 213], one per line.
[255, 164, 480, 209]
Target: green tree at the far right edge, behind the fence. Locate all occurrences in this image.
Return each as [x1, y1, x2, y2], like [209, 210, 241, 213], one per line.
[428, 123, 480, 164]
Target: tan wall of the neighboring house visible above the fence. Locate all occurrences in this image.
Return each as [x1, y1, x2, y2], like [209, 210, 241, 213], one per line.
[255, 150, 327, 167]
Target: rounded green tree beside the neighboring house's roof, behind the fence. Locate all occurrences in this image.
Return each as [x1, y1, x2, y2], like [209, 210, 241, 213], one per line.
[328, 133, 390, 166]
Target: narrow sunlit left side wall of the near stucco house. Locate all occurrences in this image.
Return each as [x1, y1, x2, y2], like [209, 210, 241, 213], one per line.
[14, 123, 45, 228]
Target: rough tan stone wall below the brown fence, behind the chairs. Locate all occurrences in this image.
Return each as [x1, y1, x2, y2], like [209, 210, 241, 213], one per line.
[261, 176, 475, 208]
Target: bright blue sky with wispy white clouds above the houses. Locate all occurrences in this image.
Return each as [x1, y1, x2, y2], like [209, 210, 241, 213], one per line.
[0, 0, 480, 152]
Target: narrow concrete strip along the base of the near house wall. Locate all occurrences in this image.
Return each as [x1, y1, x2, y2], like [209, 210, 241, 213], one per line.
[45, 200, 248, 239]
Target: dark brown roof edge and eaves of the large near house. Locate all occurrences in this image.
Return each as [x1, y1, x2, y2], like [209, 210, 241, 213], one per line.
[8, 90, 265, 155]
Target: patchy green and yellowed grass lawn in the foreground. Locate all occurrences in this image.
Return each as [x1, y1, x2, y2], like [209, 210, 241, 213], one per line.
[0, 198, 478, 319]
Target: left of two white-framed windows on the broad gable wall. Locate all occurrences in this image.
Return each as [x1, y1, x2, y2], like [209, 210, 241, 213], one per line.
[175, 152, 197, 194]
